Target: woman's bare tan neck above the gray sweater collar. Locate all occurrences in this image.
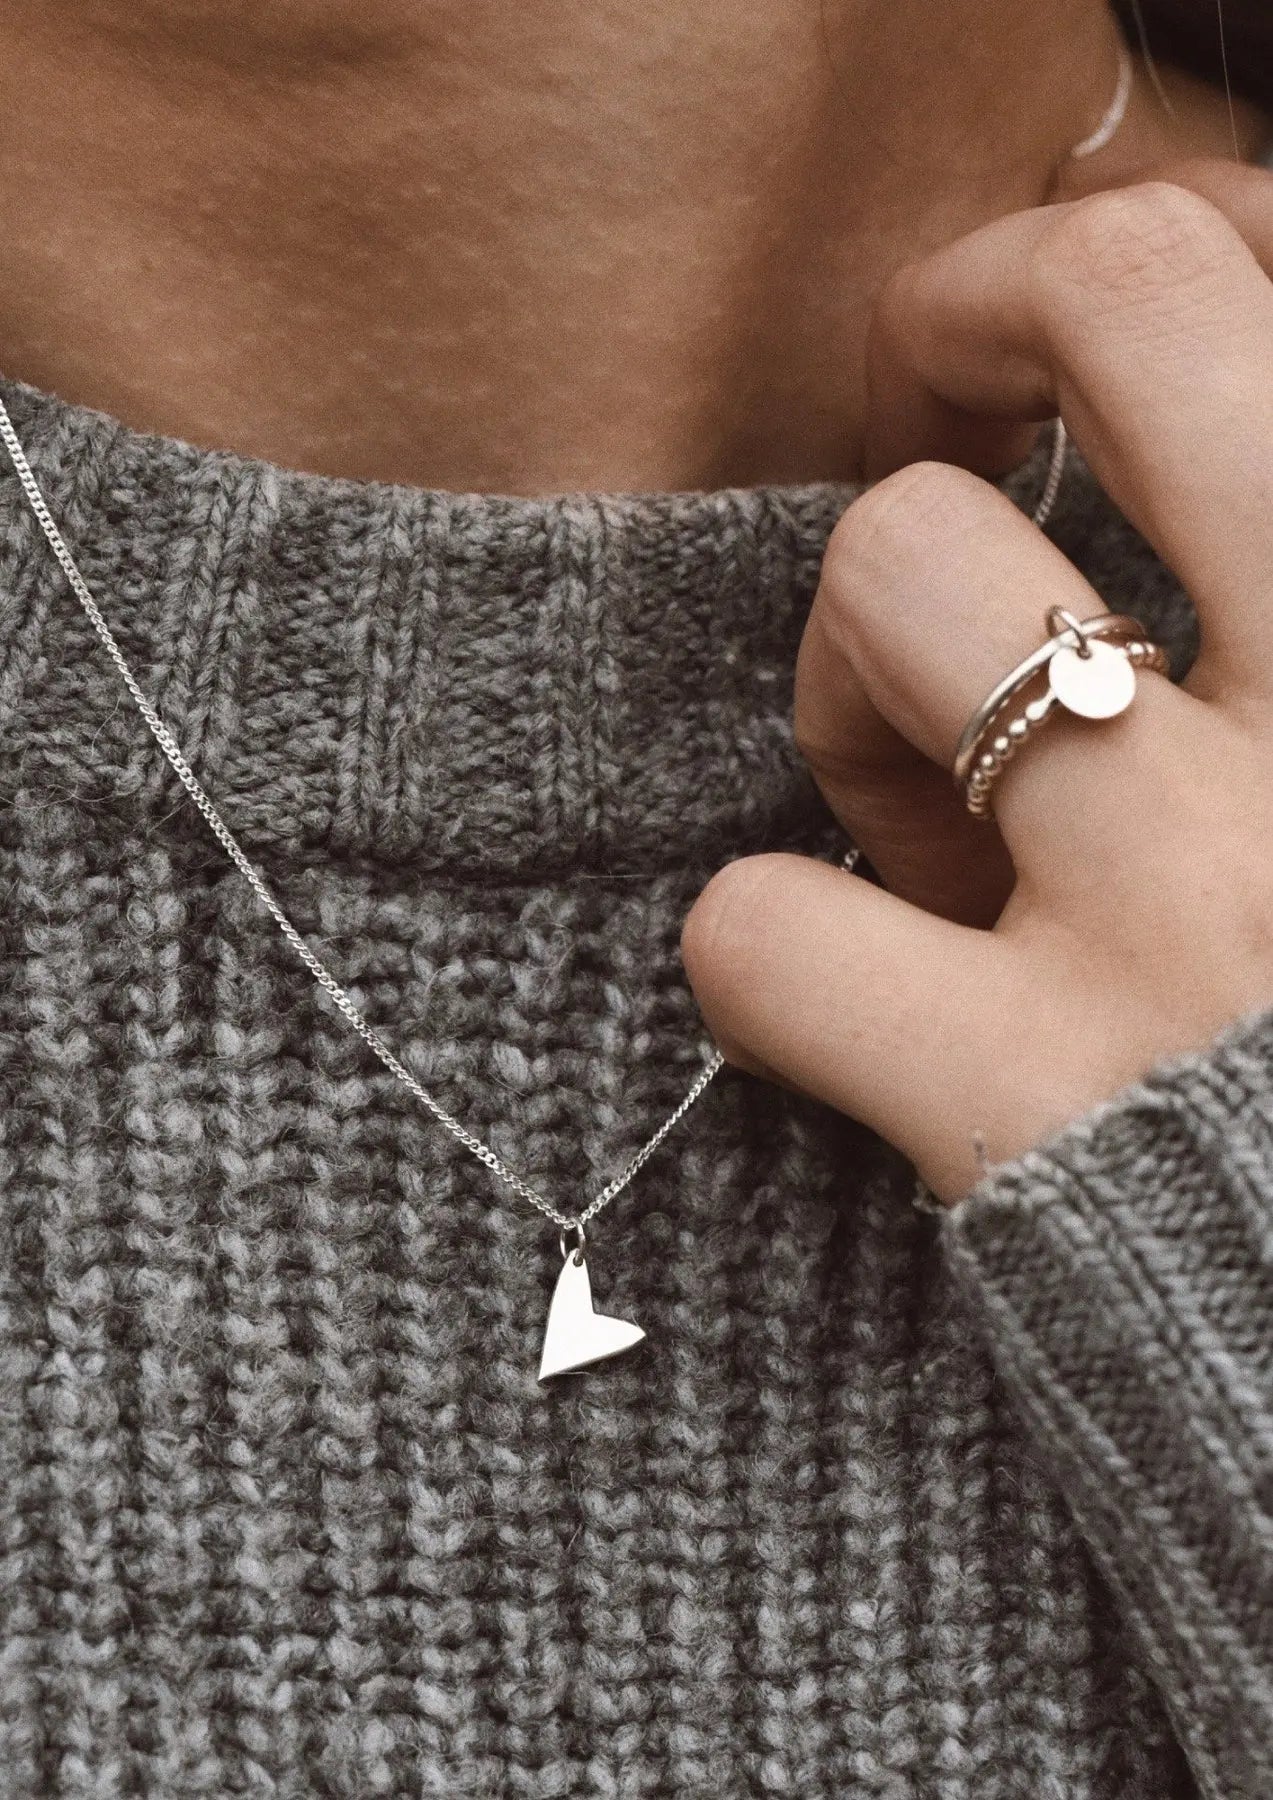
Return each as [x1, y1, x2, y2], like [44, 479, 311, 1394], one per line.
[0, 0, 1255, 493]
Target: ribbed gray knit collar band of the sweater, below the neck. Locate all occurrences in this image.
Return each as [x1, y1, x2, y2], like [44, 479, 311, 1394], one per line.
[0, 380, 1058, 877]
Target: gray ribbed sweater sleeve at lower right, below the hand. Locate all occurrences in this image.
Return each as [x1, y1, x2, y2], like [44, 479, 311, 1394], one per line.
[942, 1012, 1273, 1800]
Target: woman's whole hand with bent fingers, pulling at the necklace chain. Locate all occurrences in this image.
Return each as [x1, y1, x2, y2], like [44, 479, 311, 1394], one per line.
[684, 164, 1273, 1201]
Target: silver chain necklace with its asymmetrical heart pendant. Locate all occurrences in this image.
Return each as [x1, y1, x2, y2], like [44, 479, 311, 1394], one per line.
[0, 400, 1066, 1381]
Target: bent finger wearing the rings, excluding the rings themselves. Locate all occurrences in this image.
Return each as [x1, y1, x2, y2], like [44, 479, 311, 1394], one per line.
[796, 463, 1208, 892]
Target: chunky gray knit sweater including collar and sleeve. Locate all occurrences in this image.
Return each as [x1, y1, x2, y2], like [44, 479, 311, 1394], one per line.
[0, 369, 1273, 1800]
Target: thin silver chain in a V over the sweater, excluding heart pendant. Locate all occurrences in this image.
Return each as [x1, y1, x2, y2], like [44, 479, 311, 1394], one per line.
[0, 400, 724, 1231]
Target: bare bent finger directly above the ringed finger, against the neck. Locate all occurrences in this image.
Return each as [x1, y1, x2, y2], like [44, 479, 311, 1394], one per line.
[868, 164, 1273, 691]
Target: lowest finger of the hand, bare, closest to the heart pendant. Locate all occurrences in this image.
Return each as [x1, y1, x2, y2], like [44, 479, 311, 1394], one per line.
[681, 855, 1019, 1197]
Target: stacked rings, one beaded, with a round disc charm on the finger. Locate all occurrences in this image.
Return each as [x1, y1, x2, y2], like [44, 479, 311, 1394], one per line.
[954, 607, 1167, 819]
